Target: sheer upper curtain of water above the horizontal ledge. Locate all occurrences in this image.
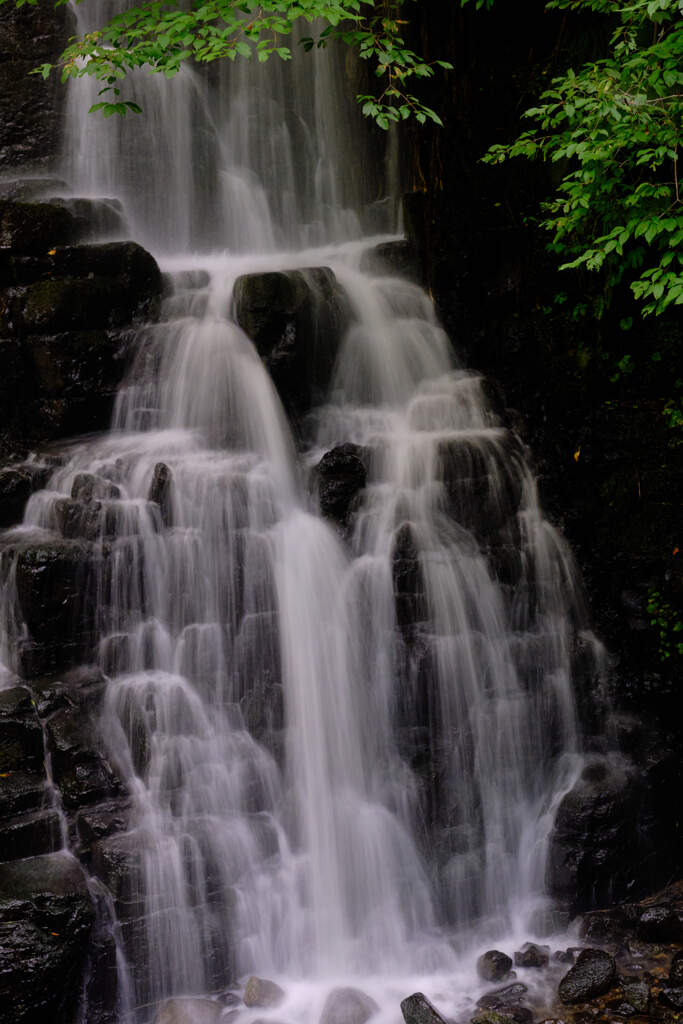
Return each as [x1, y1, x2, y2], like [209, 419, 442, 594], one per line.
[61, 0, 396, 252]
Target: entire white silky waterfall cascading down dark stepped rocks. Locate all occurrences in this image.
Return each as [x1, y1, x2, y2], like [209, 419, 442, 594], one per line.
[0, 10, 610, 1024]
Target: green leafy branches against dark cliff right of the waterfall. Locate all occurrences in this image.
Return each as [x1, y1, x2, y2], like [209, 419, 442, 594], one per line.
[484, 0, 683, 315]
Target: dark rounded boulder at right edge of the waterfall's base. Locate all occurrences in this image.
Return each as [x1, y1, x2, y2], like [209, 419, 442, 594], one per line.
[548, 755, 640, 909]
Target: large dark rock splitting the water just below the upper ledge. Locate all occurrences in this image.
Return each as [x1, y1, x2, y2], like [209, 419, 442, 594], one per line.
[233, 267, 349, 415]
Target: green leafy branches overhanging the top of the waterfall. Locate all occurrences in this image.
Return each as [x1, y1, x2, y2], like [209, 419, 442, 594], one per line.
[5, 0, 456, 129]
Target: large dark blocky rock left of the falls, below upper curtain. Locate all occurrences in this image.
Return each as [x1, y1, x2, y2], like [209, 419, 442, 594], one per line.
[0, 242, 161, 439]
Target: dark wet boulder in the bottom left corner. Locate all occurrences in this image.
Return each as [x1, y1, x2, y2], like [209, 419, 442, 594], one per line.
[0, 853, 93, 1024]
